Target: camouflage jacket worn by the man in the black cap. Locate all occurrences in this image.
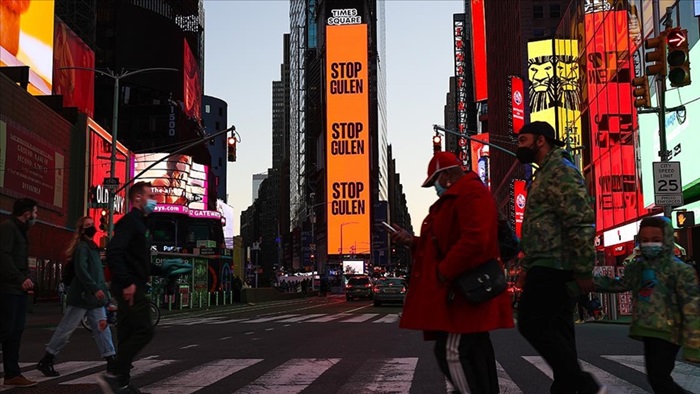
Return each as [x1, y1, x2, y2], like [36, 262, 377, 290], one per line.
[522, 148, 595, 279]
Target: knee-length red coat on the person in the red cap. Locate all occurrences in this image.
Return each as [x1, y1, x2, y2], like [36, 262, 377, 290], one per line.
[400, 172, 514, 338]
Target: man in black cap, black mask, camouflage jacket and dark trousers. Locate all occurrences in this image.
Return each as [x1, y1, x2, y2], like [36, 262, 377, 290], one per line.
[517, 121, 606, 394]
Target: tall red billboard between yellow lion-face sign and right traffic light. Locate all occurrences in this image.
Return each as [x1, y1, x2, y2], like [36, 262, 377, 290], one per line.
[585, 11, 646, 232]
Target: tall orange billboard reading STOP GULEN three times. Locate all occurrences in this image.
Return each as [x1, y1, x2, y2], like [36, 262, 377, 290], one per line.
[326, 24, 370, 254]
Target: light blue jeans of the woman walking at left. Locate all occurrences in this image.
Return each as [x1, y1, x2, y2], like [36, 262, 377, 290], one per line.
[46, 305, 116, 358]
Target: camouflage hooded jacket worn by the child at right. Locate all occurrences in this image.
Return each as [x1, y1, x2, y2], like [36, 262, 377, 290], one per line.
[595, 219, 700, 360]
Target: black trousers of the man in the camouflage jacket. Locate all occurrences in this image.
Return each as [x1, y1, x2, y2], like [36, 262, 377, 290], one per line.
[518, 267, 599, 394]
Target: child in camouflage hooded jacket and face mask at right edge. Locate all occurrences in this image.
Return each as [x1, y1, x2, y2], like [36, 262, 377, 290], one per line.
[595, 217, 700, 394]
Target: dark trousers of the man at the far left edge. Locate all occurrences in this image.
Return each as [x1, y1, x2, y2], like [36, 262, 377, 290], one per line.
[0, 294, 28, 380]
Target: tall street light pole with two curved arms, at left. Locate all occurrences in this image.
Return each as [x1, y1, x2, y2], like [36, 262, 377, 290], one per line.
[60, 67, 178, 240]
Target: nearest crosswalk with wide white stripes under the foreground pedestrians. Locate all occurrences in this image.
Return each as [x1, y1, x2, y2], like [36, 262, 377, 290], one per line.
[0, 355, 700, 394]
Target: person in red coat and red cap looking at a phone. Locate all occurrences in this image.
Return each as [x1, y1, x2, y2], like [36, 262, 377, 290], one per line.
[392, 152, 514, 394]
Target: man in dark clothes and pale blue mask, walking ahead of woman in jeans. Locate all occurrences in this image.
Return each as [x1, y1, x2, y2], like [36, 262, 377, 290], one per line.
[97, 182, 164, 394]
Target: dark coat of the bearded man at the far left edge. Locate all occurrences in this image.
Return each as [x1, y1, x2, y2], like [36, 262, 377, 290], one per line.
[0, 216, 29, 295]
